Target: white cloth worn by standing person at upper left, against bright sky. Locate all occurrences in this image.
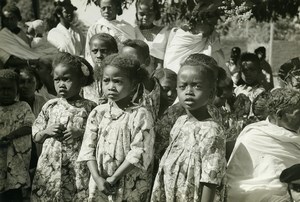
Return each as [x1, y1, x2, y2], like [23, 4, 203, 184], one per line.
[47, 23, 84, 56]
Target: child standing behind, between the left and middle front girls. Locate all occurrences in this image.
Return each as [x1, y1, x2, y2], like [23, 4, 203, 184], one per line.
[83, 33, 118, 104]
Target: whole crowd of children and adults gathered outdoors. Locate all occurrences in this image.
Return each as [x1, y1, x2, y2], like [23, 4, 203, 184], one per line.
[0, 0, 300, 202]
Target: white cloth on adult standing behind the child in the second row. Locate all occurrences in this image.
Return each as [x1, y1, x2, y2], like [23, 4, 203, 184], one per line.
[85, 17, 136, 64]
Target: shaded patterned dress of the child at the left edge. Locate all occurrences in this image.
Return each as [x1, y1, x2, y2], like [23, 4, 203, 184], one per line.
[0, 102, 35, 193]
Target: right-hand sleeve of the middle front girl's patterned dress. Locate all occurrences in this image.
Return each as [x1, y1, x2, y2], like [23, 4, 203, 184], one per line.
[126, 108, 155, 170]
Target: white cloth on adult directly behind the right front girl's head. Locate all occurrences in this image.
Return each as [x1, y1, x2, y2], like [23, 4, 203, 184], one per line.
[164, 28, 230, 77]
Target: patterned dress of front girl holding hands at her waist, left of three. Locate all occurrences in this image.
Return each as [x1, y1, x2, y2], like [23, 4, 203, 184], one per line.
[32, 98, 96, 202]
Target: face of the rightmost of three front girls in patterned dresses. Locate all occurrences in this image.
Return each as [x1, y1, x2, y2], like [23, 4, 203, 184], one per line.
[177, 65, 213, 111]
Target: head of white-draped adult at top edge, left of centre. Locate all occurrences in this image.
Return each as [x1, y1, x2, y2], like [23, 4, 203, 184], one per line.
[99, 0, 122, 21]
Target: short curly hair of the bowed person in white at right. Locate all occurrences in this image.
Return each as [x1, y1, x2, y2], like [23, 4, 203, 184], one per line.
[267, 88, 300, 114]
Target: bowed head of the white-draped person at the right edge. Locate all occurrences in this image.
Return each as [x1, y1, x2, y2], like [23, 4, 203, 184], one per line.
[267, 88, 300, 134]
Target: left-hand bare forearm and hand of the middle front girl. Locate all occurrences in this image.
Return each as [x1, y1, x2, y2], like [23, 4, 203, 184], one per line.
[87, 160, 113, 195]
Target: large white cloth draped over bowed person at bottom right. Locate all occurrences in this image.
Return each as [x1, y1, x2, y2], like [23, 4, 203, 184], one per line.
[227, 120, 300, 202]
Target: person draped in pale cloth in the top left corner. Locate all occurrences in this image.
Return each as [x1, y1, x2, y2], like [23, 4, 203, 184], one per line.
[0, 3, 40, 69]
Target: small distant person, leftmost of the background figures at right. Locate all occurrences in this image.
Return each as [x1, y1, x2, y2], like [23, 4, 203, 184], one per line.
[226, 47, 241, 86]
